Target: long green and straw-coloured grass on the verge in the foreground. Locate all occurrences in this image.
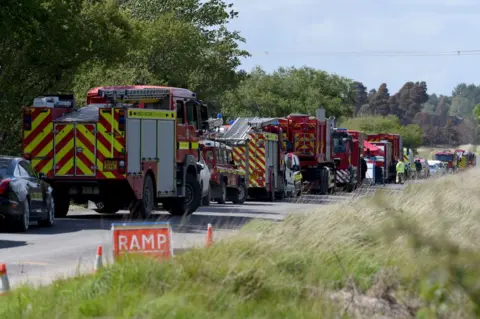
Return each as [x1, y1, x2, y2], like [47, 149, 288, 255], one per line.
[0, 170, 480, 319]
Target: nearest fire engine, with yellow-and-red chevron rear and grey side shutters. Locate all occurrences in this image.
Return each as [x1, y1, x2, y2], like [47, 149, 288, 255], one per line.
[23, 86, 208, 218]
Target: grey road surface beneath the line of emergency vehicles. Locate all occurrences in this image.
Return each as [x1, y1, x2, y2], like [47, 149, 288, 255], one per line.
[0, 185, 403, 288]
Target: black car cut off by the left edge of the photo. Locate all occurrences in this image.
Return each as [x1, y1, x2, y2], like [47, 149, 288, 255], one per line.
[0, 156, 55, 232]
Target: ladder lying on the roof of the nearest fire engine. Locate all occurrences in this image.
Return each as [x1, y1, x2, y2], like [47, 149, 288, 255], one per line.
[98, 88, 170, 102]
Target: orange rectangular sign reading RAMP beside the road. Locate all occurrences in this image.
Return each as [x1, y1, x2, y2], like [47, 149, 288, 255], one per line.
[112, 222, 173, 259]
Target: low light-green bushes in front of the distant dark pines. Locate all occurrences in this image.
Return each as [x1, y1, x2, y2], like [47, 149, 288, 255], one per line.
[341, 115, 423, 150]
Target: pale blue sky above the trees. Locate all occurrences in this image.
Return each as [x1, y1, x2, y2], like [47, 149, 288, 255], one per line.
[229, 0, 480, 95]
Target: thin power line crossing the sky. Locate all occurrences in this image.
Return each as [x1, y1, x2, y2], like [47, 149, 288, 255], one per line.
[247, 49, 480, 57]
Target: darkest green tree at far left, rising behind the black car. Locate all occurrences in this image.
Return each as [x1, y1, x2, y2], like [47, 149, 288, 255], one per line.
[0, 0, 134, 154]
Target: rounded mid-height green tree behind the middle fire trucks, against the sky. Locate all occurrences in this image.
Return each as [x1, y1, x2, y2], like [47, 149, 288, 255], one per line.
[221, 67, 354, 117]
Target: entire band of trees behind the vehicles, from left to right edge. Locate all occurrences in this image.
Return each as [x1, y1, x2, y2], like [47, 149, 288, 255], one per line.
[0, 0, 480, 154]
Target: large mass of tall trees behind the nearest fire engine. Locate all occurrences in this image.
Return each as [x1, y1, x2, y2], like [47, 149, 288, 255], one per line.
[0, 0, 248, 154]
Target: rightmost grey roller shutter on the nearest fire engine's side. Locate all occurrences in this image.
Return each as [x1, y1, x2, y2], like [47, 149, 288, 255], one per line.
[156, 120, 177, 196]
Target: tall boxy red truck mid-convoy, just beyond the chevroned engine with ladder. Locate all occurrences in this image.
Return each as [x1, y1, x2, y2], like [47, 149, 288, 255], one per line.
[279, 109, 336, 194]
